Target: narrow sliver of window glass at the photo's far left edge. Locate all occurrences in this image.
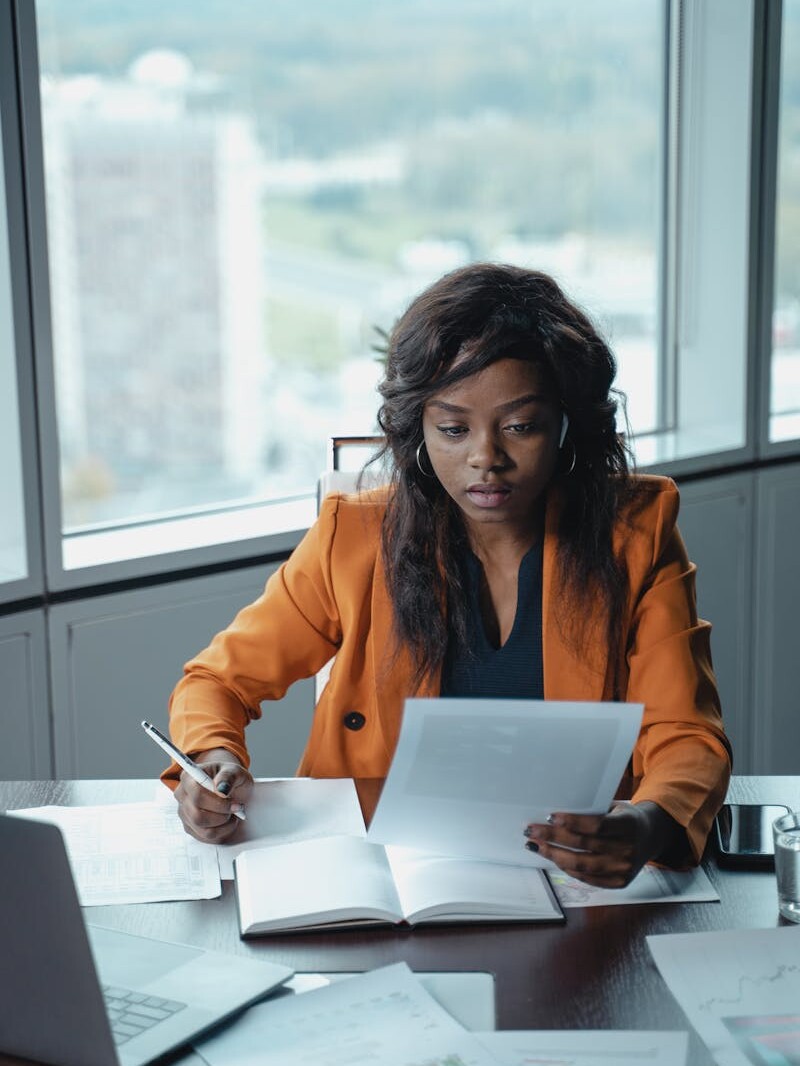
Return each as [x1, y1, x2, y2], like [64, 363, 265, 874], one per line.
[0, 102, 29, 584]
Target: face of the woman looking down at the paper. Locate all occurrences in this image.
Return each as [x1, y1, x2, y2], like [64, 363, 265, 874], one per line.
[422, 359, 561, 535]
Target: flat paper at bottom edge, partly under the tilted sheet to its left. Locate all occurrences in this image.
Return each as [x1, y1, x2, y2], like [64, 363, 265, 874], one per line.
[476, 1029, 689, 1066]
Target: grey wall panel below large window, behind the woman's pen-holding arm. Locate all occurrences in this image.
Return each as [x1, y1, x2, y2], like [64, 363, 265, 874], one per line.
[49, 567, 314, 777]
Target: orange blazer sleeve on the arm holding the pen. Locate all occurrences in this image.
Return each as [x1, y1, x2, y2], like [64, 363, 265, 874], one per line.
[161, 496, 341, 788]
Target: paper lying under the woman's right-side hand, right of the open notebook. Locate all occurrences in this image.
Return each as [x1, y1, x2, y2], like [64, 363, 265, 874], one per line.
[547, 866, 719, 907]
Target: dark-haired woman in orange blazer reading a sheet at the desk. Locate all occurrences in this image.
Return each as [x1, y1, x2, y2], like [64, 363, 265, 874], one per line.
[165, 264, 730, 887]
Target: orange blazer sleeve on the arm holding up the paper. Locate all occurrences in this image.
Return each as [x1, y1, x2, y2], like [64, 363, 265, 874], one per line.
[627, 482, 731, 866]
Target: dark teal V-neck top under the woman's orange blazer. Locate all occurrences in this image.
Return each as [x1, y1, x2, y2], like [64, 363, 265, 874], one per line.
[442, 537, 544, 699]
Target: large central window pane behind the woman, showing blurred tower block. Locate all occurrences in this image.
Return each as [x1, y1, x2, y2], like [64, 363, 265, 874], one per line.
[37, 0, 665, 528]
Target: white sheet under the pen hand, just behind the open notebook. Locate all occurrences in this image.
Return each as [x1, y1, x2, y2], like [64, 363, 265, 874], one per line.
[194, 777, 366, 881]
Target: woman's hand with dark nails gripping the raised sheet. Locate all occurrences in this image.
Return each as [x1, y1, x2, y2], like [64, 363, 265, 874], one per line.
[525, 801, 683, 888]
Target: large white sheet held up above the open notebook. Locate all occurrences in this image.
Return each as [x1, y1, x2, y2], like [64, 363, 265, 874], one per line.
[368, 699, 643, 867]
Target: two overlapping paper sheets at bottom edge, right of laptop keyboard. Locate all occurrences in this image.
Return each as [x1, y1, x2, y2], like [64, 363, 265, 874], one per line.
[195, 963, 687, 1066]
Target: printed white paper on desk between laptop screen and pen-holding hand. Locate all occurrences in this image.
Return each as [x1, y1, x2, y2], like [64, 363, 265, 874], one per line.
[9, 803, 222, 907]
